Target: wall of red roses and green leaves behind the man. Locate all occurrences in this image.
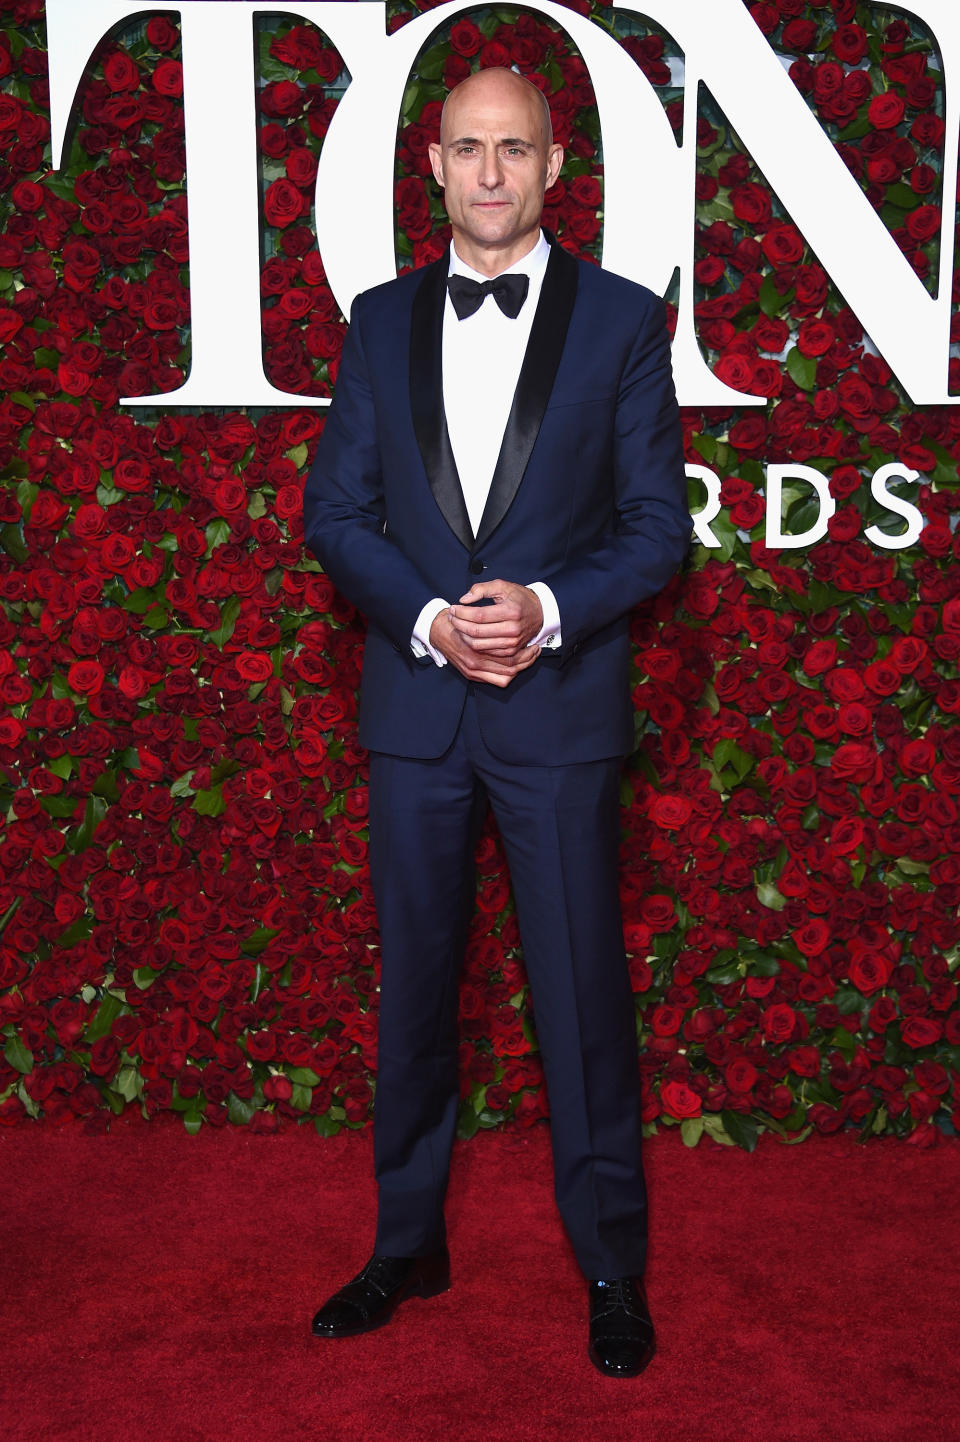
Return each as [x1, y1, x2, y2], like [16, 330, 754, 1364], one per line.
[0, 0, 960, 1146]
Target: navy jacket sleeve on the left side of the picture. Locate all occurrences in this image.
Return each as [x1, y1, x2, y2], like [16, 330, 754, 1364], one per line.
[303, 296, 434, 650]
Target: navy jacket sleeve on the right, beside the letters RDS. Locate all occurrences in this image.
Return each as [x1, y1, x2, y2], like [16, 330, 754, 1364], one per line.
[543, 297, 693, 658]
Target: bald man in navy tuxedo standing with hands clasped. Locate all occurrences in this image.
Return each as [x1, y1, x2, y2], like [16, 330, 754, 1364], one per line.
[304, 69, 690, 1376]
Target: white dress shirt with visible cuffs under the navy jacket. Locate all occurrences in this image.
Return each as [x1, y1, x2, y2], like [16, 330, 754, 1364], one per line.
[411, 231, 561, 666]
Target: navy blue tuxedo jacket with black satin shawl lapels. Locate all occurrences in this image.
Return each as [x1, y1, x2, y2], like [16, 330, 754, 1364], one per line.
[304, 244, 690, 766]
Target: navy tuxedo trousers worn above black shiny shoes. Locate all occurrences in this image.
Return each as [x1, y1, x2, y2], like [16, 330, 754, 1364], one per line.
[370, 686, 647, 1278]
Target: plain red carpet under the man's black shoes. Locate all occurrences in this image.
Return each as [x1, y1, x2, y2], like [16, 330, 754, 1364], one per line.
[0, 1125, 960, 1442]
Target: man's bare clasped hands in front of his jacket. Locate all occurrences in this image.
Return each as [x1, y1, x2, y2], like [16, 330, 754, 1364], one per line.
[430, 581, 543, 686]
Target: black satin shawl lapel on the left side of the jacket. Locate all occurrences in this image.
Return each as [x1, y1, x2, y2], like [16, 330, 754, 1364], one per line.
[409, 252, 473, 551]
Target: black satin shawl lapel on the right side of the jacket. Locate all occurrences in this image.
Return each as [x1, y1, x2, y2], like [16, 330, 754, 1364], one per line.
[474, 242, 578, 549]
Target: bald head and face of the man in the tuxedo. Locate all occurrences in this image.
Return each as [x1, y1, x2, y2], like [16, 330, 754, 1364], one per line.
[430, 69, 564, 274]
